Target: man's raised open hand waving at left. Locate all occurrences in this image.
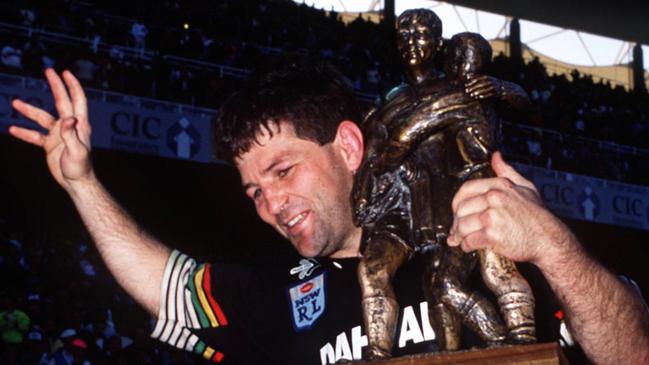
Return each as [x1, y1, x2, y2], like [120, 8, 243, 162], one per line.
[9, 69, 93, 191]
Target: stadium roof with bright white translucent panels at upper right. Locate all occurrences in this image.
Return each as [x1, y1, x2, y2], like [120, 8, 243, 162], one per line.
[302, 0, 649, 75]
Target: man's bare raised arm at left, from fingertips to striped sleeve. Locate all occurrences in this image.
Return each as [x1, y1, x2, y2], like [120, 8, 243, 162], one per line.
[9, 69, 170, 316]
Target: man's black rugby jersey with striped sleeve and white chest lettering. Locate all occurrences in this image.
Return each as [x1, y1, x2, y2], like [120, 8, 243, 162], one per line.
[152, 251, 560, 364]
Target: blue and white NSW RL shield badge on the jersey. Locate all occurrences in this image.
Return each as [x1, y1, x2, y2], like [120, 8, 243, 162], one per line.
[288, 272, 326, 332]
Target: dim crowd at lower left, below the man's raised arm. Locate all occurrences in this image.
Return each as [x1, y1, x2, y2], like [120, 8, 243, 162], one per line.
[0, 219, 207, 365]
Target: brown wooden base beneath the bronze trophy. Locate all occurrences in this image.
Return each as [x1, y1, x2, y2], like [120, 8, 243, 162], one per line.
[358, 342, 569, 365]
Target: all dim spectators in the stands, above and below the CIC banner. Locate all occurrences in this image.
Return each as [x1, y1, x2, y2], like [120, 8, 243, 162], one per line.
[0, 0, 649, 365]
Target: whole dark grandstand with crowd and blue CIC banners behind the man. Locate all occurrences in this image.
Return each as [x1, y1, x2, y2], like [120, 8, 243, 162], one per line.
[0, 0, 649, 365]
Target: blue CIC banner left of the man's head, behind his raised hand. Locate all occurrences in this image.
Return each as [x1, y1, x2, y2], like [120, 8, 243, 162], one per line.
[0, 75, 216, 163]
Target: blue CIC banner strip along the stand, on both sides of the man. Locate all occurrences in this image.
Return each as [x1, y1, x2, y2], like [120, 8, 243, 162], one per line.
[0, 74, 649, 230]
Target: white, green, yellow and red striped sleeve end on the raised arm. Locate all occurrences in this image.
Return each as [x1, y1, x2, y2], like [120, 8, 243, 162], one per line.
[151, 250, 228, 362]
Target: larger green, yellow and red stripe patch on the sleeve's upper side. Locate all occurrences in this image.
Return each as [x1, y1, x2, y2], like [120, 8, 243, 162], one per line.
[187, 264, 228, 328]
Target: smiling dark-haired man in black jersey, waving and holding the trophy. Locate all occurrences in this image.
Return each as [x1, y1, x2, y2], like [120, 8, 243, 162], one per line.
[10, 63, 649, 364]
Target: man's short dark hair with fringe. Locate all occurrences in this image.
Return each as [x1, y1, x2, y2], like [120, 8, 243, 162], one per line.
[213, 62, 361, 162]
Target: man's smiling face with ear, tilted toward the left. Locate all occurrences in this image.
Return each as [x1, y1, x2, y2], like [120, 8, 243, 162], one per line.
[235, 123, 362, 257]
